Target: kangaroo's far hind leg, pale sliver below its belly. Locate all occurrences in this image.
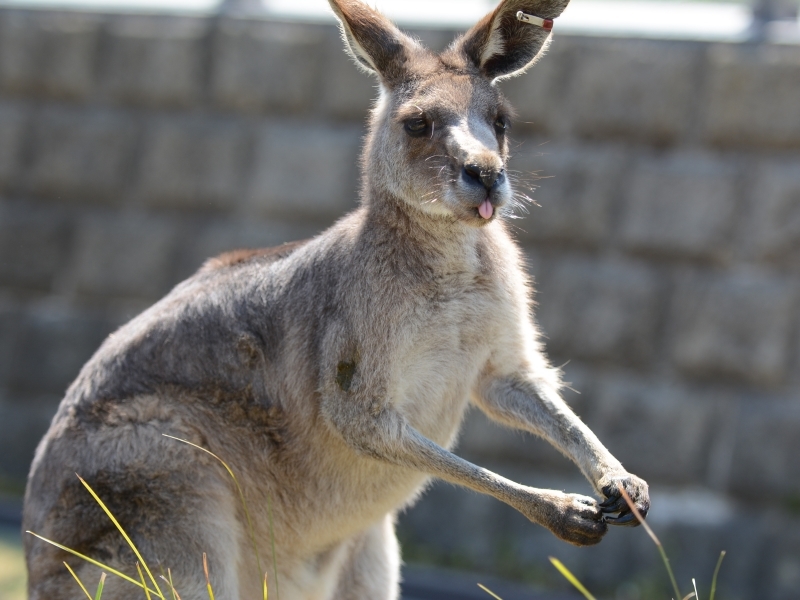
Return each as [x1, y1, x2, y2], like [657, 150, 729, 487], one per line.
[333, 514, 400, 600]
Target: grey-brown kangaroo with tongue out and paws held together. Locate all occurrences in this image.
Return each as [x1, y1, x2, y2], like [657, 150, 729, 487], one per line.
[24, 0, 649, 600]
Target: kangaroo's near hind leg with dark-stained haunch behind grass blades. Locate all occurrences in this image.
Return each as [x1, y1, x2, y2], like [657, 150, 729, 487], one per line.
[25, 424, 244, 600]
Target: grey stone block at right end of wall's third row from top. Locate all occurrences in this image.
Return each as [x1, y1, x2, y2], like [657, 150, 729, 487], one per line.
[670, 272, 797, 385]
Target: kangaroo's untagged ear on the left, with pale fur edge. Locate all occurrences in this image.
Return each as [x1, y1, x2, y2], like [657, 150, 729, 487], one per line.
[328, 0, 419, 87]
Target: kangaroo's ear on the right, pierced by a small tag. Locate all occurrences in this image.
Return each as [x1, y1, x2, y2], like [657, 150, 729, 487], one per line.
[456, 0, 569, 81]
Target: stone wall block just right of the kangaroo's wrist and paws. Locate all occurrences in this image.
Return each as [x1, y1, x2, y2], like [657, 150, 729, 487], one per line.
[588, 377, 726, 485]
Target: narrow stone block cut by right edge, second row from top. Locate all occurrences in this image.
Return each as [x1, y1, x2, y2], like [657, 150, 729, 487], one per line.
[746, 160, 800, 265]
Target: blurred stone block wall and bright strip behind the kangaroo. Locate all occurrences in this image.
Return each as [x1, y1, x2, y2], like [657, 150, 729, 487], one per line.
[0, 0, 800, 600]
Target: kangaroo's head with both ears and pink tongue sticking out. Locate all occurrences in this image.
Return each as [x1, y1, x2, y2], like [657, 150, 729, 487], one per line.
[329, 0, 569, 226]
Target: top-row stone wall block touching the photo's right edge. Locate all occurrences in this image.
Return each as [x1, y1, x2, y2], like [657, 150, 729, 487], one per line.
[703, 44, 800, 149]
